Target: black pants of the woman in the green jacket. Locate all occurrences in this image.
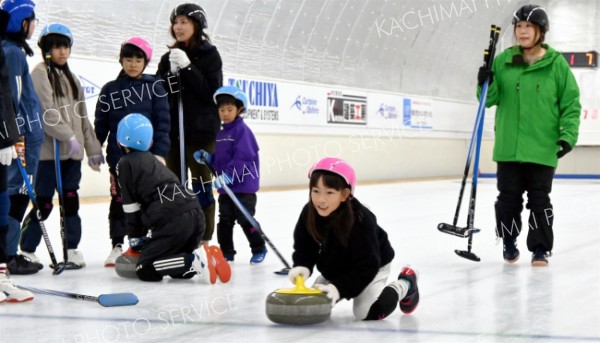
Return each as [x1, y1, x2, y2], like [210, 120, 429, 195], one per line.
[495, 162, 554, 251]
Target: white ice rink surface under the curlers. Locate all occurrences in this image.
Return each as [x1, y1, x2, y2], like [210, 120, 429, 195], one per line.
[0, 179, 600, 343]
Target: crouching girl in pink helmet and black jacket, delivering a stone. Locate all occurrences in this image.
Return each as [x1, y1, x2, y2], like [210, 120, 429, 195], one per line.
[288, 157, 419, 320]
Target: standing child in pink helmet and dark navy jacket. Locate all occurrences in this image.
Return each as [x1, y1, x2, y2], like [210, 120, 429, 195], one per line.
[94, 37, 171, 267]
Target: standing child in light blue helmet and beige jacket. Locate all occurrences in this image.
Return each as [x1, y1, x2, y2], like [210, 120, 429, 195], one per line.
[20, 23, 104, 269]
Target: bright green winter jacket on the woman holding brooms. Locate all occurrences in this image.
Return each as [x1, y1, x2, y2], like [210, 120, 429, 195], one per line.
[477, 44, 581, 167]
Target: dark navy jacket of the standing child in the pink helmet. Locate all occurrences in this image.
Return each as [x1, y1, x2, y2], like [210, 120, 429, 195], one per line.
[94, 73, 171, 166]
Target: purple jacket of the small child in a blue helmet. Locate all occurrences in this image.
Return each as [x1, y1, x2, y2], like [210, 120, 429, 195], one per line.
[213, 117, 260, 194]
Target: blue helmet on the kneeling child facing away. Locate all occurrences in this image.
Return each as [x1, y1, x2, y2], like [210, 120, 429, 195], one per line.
[117, 113, 154, 151]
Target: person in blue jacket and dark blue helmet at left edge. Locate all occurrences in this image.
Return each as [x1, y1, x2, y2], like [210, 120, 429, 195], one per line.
[0, 0, 44, 275]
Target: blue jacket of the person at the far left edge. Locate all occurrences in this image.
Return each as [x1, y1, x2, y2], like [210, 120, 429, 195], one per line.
[2, 40, 44, 145]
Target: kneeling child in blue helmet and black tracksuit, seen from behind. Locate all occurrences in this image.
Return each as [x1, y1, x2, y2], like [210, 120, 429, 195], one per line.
[116, 113, 225, 281]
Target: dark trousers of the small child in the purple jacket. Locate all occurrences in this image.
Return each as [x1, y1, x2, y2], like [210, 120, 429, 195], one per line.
[217, 193, 265, 255]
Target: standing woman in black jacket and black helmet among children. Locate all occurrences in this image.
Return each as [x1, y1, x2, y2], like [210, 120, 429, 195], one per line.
[157, 4, 223, 243]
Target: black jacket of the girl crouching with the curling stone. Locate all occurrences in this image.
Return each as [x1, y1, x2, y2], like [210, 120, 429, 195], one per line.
[293, 198, 394, 299]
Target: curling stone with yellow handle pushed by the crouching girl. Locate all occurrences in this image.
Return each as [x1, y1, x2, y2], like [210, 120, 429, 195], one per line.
[267, 276, 331, 325]
